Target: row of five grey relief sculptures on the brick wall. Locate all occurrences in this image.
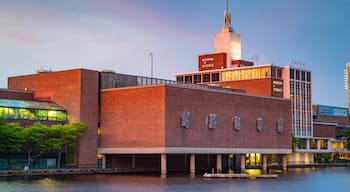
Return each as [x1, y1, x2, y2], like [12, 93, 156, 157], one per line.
[181, 111, 284, 133]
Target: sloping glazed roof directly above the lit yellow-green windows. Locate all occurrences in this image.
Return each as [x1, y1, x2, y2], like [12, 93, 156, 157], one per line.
[0, 98, 66, 111]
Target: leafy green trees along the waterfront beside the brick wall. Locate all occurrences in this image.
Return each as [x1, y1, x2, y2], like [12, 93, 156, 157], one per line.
[0, 119, 88, 168]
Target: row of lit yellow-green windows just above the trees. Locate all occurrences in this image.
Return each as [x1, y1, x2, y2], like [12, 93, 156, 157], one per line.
[0, 107, 67, 121]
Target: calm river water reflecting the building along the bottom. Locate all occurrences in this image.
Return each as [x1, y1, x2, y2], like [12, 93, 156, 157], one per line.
[0, 168, 350, 192]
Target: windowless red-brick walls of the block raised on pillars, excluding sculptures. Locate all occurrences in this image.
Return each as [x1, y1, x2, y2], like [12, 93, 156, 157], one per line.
[101, 85, 292, 152]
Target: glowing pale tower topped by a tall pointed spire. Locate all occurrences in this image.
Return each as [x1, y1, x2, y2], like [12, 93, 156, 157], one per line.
[214, 0, 241, 68]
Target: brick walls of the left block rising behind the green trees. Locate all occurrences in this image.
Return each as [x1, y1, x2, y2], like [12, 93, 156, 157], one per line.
[8, 69, 99, 166]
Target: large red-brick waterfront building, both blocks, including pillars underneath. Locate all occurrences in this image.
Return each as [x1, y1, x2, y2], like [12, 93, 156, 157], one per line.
[0, 69, 291, 173]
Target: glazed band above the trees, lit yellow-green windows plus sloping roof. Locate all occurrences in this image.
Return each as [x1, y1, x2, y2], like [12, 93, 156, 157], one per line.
[0, 99, 67, 121]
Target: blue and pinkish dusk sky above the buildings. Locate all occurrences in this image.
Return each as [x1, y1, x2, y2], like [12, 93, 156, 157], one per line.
[0, 0, 350, 107]
